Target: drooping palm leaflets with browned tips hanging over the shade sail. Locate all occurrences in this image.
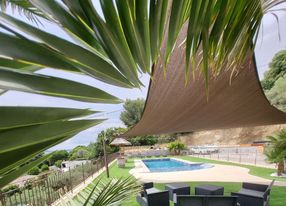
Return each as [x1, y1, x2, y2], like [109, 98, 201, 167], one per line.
[165, 0, 285, 85]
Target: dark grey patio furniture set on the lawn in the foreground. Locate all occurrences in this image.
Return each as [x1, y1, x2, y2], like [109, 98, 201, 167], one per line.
[136, 180, 274, 206]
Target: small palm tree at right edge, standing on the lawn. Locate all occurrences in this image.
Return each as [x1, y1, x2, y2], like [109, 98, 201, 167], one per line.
[265, 129, 286, 176]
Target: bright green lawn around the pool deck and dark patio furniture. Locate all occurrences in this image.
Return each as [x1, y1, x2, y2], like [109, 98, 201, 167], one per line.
[78, 156, 286, 206]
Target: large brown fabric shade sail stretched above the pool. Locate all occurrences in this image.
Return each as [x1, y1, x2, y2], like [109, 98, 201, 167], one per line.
[124, 24, 286, 136]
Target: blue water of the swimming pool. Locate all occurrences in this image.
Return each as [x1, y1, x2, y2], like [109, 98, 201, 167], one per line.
[142, 158, 213, 172]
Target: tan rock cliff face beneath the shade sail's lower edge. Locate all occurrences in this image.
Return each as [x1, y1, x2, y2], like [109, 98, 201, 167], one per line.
[180, 124, 286, 145]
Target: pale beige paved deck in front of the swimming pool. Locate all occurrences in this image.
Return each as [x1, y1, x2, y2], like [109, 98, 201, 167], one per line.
[129, 158, 286, 186]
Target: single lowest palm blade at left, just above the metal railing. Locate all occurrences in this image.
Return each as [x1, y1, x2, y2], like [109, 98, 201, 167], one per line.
[0, 120, 102, 173]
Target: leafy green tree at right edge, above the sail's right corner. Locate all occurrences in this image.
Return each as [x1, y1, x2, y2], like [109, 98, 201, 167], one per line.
[261, 50, 286, 90]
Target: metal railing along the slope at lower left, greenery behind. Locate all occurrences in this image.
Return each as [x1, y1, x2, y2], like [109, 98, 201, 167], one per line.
[0, 154, 118, 206]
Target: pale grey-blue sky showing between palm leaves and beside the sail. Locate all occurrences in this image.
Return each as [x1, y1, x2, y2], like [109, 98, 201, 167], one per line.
[0, 1, 286, 150]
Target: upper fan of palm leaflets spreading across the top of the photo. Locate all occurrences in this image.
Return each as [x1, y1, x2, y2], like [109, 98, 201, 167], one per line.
[0, 0, 283, 87]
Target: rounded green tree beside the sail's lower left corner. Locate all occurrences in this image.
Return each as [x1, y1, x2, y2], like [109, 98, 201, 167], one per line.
[120, 98, 145, 127]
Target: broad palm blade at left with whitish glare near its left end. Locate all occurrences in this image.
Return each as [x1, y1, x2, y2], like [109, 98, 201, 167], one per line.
[0, 67, 121, 103]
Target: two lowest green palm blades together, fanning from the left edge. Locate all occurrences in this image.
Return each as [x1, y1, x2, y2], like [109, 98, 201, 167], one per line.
[0, 107, 102, 184]
